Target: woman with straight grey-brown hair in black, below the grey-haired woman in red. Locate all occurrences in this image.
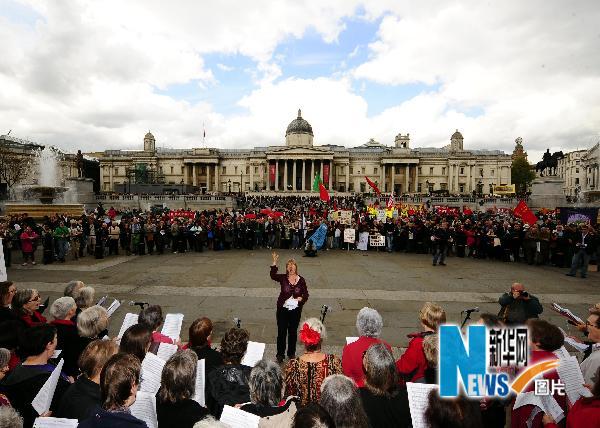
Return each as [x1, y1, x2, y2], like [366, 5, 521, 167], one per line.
[359, 343, 411, 428]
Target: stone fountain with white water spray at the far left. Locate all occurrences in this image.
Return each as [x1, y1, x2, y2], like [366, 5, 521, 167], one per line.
[6, 147, 92, 219]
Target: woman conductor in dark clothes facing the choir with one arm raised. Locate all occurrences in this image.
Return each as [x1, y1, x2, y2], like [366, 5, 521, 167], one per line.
[271, 252, 308, 363]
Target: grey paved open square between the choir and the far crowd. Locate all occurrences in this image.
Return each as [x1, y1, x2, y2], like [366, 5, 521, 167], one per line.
[8, 250, 600, 350]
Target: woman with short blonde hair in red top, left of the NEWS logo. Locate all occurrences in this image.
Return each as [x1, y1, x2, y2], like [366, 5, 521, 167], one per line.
[396, 302, 446, 382]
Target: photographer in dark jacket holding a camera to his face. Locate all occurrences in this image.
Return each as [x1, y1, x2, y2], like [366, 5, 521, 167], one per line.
[498, 282, 544, 325]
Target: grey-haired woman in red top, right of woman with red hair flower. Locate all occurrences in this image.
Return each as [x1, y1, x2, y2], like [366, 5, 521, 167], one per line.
[342, 307, 392, 388]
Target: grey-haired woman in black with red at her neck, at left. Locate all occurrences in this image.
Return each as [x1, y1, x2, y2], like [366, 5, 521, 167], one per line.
[50, 297, 79, 377]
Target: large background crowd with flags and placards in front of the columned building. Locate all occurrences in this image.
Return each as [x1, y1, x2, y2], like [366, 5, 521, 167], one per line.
[0, 196, 600, 277]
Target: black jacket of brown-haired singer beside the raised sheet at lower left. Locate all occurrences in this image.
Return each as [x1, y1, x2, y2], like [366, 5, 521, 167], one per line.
[55, 375, 102, 422]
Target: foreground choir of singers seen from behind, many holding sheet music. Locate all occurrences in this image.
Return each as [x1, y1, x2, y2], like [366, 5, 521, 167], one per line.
[0, 278, 600, 428]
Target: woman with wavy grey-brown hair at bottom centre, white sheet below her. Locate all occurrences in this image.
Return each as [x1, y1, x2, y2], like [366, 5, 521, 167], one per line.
[241, 360, 296, 426]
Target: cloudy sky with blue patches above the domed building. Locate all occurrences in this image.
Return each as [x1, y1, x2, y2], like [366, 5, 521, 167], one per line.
[0, 0, 600, 160]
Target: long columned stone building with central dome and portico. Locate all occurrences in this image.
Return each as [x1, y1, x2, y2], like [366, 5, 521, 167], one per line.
[91, 110, 512, 195]
